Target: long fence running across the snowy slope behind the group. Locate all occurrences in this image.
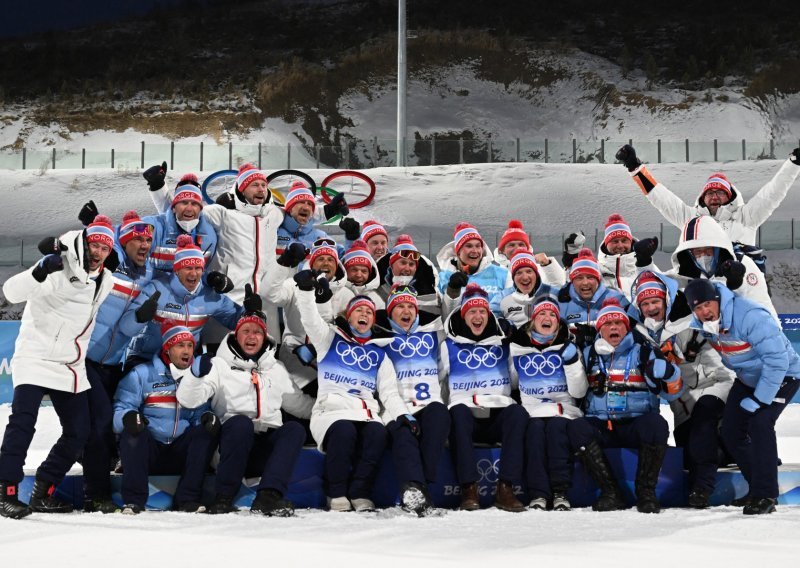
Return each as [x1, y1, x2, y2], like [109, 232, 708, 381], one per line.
[0, 136, 800, 171]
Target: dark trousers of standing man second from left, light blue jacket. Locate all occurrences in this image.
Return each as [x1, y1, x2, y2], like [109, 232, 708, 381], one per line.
[83, 359, 124, 499]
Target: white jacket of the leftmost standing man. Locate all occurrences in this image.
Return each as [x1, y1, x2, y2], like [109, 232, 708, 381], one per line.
[3, 231, 114, 393]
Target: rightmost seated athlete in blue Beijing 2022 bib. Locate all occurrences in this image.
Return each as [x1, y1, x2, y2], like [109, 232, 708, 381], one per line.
[510, 297, 589, 511]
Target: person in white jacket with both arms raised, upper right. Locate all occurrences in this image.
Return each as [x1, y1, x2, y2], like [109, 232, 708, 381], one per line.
[616, 144, 800, 245]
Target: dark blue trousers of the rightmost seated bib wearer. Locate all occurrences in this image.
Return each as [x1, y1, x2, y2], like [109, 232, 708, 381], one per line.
[525, 416, 574, 499]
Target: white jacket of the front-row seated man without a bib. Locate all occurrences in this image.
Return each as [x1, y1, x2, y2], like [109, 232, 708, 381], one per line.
[177, 334, 314, 432]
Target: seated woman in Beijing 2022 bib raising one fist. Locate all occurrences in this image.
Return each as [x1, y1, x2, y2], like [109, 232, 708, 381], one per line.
[294, 270, 414, 512]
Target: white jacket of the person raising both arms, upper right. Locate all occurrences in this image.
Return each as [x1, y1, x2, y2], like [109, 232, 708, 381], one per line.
[631, 160, 800, 245]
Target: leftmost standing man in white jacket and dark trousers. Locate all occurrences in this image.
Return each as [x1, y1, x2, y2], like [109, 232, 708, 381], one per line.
[0, 221, 118, 519]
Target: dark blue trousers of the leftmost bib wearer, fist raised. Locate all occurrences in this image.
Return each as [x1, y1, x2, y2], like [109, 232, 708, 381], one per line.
[322, 420, 386, 499]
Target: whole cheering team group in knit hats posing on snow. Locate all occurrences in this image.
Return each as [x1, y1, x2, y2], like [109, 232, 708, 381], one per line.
[0, 146, 800, 518]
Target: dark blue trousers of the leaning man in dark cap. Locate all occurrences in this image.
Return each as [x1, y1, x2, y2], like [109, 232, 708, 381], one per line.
[722, 379, 800, 498]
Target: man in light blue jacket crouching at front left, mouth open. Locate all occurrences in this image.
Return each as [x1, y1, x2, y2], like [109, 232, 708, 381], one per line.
[114, 325, 220, 515]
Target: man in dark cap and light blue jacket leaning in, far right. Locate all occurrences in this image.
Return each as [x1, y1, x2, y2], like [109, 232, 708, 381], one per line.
[685, 279, 800, 515]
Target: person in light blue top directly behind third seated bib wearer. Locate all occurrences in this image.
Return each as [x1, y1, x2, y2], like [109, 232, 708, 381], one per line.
[436, 222, 514, 319]
